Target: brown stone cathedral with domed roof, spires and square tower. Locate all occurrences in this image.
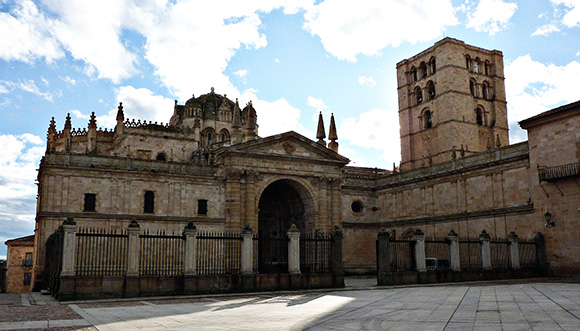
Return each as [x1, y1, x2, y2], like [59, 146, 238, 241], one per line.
[34, 38, 580, 290]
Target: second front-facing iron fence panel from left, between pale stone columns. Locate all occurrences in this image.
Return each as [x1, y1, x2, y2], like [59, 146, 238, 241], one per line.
[139, 231, 185, 276]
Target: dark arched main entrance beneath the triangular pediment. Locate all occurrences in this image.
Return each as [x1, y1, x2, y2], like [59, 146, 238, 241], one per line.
[258, 179, 314, 273]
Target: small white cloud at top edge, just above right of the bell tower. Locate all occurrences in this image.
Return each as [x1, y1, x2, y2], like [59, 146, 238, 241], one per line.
[466, 0, 518, 35]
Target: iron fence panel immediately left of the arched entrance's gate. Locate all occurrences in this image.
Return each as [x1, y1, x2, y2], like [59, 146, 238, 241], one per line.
[196, 231, 242, 275]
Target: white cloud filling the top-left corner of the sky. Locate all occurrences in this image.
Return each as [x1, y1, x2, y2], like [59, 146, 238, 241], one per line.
[0, 0, 64, 63]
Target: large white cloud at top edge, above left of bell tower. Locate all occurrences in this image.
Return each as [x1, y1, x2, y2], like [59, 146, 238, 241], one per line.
[304, 0, 458, 61]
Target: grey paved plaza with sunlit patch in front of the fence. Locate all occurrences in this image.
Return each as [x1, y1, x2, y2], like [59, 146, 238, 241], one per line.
[0, 280, 580, 331]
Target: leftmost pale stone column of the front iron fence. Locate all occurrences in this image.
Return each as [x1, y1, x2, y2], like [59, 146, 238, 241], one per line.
[58, 217, 77, 300]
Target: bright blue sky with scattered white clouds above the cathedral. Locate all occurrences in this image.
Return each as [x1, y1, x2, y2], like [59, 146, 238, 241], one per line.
[0, 0, 580, 258]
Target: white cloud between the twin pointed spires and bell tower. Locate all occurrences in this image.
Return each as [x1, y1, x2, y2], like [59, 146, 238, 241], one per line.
[338, 109, 401, 164]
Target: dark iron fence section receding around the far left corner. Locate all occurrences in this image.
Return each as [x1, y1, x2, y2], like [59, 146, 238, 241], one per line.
[43, 227, 64, 294]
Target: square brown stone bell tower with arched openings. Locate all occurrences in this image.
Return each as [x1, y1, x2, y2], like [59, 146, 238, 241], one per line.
[397, 38, 509, 170]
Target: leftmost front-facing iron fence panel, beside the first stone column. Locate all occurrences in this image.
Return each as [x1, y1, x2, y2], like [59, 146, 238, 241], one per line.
[75, 228, 128, 276]
